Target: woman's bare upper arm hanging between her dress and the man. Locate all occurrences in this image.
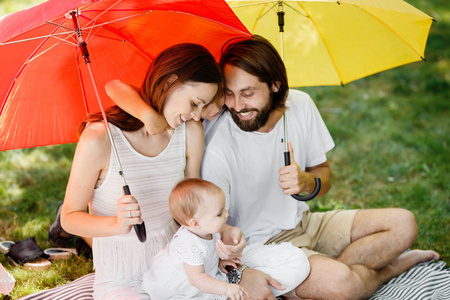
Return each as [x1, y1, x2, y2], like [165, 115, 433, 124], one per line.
[184, 120, 204, 178]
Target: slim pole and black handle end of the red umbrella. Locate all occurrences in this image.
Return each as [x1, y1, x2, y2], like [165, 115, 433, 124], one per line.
[70, 11, 147, 243]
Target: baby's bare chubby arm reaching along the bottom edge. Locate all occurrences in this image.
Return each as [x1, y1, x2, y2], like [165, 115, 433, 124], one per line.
[183, 263, 246, 299]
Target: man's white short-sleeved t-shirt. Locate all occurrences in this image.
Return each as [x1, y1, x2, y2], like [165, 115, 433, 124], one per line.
[201, 90, 334, 244]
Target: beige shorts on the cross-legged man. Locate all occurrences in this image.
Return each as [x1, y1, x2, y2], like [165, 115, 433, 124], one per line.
[266, 210, 358, 258]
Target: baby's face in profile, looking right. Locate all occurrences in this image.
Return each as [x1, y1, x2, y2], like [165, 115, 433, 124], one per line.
[197, 191, 228, 234]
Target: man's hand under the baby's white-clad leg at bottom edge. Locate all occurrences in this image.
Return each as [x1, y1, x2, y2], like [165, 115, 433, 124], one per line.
[239, 268, 286, 300]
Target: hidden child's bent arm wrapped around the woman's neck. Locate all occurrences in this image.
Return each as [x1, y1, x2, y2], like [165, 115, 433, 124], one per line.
[105, 79, 171, 135]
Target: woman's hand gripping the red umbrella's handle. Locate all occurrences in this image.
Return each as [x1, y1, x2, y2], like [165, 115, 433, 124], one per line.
[116, 195, 143, 234]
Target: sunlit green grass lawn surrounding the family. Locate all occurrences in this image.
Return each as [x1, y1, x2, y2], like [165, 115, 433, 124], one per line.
[0, 0, 450, 299]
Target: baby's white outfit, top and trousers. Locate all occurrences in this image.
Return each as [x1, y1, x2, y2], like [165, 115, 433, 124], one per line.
[142, 227, 310, 300]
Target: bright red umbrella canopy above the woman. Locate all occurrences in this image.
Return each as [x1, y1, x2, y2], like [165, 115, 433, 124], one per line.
[0, 0, 250, 151]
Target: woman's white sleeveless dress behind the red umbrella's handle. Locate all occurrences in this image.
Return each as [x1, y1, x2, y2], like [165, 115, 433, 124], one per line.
[91, 124, 186, 299]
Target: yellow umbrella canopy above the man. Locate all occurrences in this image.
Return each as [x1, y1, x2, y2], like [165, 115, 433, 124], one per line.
[227, 0, 434, 87]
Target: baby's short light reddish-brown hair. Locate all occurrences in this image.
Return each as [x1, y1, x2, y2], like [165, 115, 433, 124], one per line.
[169, 178, 221, 226]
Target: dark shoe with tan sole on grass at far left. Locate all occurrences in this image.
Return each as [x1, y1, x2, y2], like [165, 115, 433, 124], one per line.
[0, 237, 51, 271]
